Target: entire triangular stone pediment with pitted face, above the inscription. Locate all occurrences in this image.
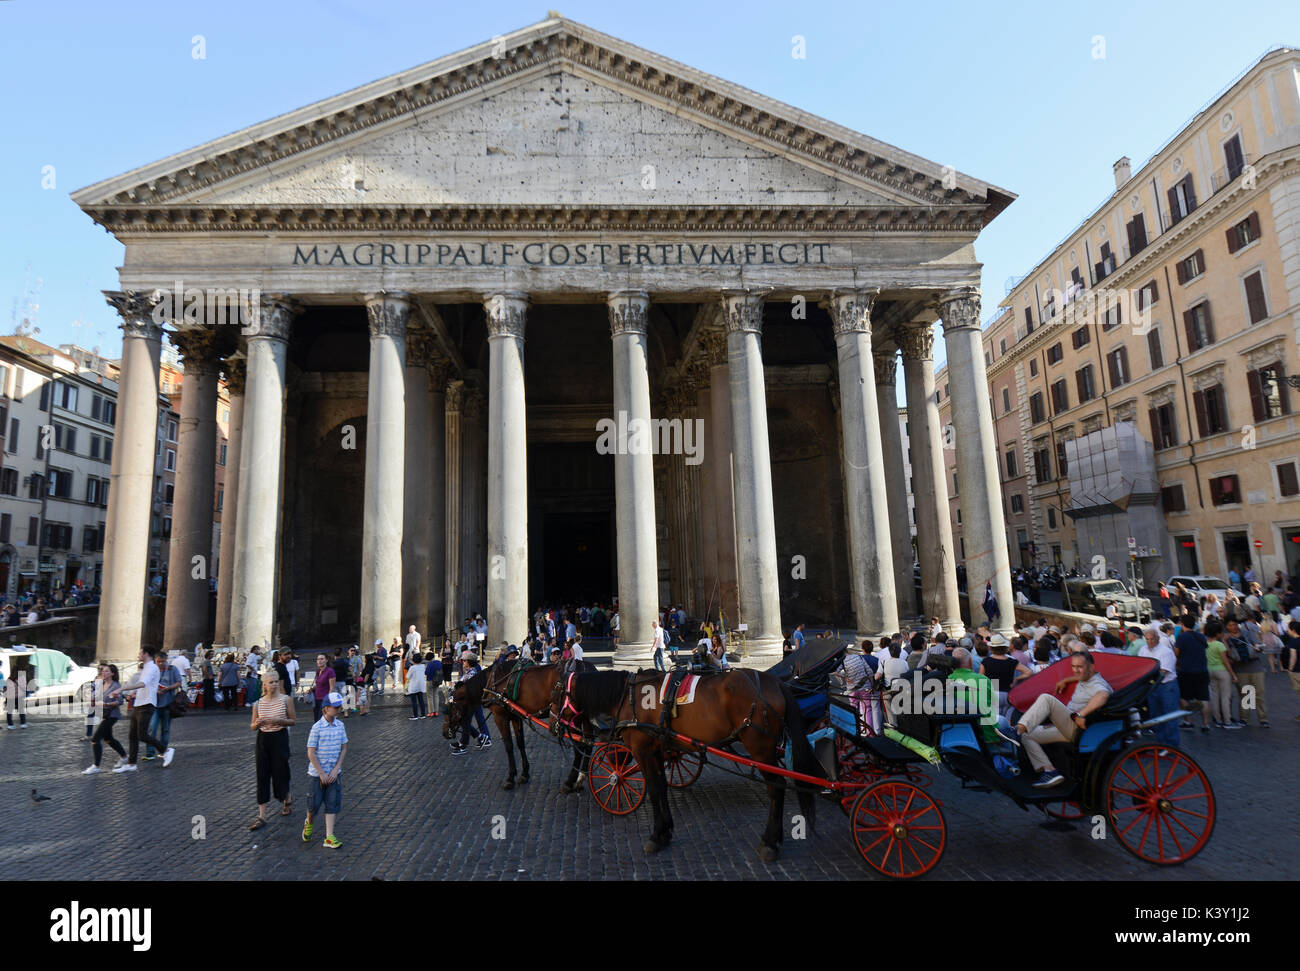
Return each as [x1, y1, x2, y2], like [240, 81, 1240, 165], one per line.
[73, 18, 1014, 222]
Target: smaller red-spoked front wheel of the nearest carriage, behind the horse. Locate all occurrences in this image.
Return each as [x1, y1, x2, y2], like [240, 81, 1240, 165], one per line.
[849, 779, 948, 879]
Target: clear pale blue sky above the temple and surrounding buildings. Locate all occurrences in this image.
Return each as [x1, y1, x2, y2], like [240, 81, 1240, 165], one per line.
[0, 0, 1300, 374]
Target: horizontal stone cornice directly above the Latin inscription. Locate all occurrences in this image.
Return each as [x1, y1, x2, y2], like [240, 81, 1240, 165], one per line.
[85, 204, 984, 235]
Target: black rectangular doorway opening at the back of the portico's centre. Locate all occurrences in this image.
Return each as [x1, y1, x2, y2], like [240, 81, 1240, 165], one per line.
[541, 512, 615, 603]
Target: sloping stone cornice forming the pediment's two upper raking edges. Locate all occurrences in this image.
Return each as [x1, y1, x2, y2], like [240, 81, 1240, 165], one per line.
[74, 18, 1013, 222]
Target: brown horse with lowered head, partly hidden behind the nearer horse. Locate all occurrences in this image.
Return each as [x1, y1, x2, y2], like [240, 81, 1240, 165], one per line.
[442, 660, 592, 793]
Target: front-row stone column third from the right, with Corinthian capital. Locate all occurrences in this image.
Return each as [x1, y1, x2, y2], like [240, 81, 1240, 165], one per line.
[723, 291, 781, 667]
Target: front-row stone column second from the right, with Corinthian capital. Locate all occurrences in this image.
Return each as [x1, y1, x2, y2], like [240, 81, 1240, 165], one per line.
[831, 290, 898, 638]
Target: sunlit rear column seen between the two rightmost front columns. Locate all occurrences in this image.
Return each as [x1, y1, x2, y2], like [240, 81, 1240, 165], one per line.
[901, 324, 966, 634]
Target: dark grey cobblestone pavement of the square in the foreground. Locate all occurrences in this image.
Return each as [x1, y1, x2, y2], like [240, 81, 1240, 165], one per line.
[0, 675, 1300, 880]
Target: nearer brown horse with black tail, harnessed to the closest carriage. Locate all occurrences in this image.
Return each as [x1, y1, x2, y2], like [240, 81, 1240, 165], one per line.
[551, 671, 826, 862]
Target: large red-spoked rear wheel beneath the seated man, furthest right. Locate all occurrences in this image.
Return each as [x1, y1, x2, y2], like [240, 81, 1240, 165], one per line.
[1106, 745, 1214, 866]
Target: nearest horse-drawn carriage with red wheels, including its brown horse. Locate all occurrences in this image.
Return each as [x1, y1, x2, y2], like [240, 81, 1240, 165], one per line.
[452, 642, 1214, 877]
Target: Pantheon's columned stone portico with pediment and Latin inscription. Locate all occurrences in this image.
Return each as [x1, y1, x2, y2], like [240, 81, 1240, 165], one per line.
[74, 18, 1013, 667]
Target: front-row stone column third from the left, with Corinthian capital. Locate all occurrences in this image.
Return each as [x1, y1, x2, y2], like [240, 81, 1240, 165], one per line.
[360, 294, 411, 657]
